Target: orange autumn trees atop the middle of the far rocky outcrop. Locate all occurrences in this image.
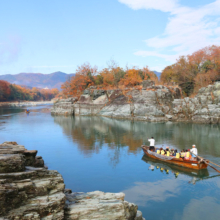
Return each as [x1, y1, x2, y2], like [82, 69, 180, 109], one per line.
[61, 61, 158, 96]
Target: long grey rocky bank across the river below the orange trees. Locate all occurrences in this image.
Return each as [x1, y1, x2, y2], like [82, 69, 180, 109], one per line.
[51, 81, 220, 124]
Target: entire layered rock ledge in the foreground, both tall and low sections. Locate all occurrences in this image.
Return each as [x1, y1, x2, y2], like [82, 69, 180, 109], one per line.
[0, 142, 144, 220]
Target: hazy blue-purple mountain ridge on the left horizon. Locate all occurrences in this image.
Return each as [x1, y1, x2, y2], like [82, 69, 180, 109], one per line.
[0, 72, 75, 90]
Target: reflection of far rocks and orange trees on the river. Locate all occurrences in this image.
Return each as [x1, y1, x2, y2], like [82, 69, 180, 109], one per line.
[54, 116, 220, 157]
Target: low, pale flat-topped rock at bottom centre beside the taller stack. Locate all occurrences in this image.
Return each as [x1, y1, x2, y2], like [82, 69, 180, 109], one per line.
[65, 191, 143, 220]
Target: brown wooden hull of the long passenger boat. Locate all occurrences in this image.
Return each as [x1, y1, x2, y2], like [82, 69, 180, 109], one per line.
[141, 145, 209, 170]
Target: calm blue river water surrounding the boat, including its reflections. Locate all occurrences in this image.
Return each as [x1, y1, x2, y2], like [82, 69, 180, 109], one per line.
[0, 106, 220, 220]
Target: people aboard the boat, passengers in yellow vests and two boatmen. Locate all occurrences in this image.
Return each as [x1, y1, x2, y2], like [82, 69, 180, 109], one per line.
[148, 137, 198, 160]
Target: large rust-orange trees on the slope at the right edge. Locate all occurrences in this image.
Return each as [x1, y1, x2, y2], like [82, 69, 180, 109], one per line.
[161, 45, 220, 95]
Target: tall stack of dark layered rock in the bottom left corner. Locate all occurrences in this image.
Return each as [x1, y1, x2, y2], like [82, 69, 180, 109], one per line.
[0, 142, 66, 220]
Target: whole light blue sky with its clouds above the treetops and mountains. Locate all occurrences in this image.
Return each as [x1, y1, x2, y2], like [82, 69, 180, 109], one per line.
[0, 0, 220, 75]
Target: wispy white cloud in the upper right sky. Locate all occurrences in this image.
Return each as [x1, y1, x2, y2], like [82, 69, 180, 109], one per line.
[119, 0, 220, 65]
